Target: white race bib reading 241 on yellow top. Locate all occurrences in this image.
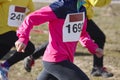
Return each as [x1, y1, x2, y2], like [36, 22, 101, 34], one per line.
[8, 5, 26, 27]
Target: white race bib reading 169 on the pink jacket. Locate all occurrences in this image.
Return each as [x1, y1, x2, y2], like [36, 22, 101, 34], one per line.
[63, 12, 85, 42]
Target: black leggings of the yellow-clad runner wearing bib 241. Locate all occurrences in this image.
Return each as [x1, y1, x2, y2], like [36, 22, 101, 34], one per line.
[0, 31, 35, 66]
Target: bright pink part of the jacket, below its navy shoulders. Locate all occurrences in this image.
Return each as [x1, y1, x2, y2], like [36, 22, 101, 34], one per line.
[17, 6, 98, 62]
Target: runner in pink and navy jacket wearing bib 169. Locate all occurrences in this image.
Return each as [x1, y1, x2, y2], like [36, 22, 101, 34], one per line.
[15, 0, 103, 80]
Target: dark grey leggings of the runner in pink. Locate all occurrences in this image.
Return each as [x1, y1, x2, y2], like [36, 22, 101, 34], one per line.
[37, 60, 89, 80]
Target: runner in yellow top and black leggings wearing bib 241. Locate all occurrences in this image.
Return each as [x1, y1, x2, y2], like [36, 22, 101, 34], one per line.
[0, 0, 35, 80]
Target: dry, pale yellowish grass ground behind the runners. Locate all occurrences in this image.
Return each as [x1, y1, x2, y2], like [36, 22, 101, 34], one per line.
[0, 4, 120, 80]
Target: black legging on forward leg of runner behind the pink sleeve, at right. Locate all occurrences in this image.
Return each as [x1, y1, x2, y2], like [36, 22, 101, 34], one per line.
[87, 20, 106, 67]
